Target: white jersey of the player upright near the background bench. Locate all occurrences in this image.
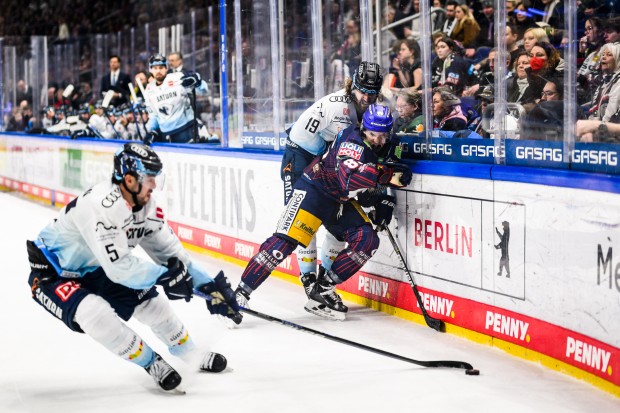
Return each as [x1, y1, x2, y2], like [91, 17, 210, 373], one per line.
[145, 72, 206, 135]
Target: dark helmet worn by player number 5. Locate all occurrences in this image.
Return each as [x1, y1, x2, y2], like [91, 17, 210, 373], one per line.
[112, 142, 163, 183]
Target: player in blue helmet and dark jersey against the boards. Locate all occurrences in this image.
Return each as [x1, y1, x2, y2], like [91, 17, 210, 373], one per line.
[236, 104, 412, 322]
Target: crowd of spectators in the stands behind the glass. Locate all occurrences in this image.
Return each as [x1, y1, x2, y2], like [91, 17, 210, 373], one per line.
[6, 0, 620, 141]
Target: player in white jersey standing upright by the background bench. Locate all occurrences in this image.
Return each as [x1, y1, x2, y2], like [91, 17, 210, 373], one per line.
[145, 54, 208, 143]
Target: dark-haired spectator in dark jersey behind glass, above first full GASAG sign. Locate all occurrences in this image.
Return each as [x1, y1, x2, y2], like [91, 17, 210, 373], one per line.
[431, 37, 470, 96]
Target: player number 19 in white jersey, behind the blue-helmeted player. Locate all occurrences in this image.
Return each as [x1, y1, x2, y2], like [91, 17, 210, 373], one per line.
[280, 62, 383, 309]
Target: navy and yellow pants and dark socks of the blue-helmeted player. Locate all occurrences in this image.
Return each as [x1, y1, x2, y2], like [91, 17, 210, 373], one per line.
[241, 181, 379, 292]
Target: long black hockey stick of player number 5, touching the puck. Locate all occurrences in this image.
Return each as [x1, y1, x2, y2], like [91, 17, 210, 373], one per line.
[241, 307, 473, 371]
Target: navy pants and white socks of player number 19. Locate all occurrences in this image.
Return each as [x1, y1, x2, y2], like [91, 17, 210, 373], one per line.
[280, 139, 345, 274]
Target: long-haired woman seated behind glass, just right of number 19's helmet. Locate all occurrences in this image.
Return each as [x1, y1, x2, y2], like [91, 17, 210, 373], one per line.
[386, 38, 422, 92]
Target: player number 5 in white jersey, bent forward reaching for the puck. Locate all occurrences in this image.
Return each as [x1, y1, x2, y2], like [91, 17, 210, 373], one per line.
[27, 143, 239, 390]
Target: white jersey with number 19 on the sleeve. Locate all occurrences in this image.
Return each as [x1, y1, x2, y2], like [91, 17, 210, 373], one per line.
[289, 89, 360, 155]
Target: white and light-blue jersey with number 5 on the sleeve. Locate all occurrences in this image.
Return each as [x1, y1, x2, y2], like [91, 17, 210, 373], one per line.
[37, 182, 212, 289]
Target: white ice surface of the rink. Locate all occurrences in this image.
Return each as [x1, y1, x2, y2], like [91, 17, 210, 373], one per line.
[0, 193, 620, 413]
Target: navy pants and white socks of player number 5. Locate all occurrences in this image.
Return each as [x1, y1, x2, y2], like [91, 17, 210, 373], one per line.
[29, 268, 194, 367]
